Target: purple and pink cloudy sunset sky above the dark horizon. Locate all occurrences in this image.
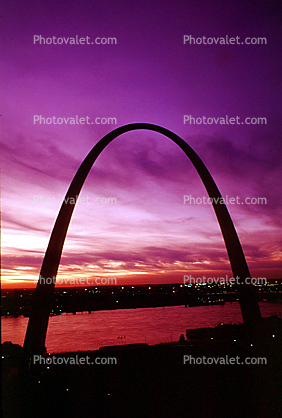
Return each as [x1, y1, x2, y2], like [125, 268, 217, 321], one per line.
[1, 0, 282, 287]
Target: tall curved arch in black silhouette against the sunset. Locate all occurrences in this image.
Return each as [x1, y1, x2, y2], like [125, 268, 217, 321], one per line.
[24, 123, 261, 352]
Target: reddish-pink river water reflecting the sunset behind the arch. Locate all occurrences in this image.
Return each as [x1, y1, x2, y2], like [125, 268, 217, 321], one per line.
[1, 302, 282, 353]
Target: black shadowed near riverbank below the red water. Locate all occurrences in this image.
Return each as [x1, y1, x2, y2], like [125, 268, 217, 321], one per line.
[2, 320, 282, 418]
